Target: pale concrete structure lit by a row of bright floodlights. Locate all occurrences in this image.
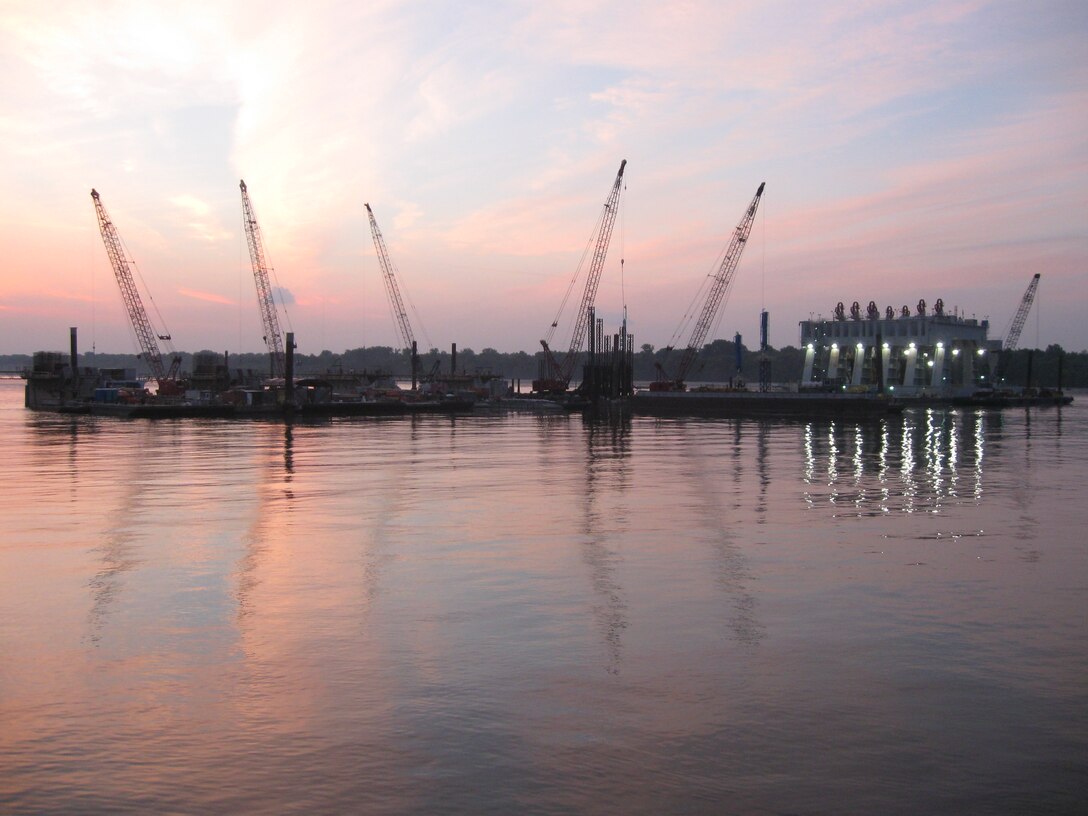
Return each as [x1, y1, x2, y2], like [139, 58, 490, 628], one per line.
[801, 300, 1001, 398]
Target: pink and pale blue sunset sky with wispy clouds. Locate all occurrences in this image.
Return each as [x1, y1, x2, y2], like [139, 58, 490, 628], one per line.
[0, 0, 1088, 354]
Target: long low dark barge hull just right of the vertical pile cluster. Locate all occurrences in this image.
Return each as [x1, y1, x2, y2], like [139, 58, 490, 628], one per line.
[630, 391, 903, 419]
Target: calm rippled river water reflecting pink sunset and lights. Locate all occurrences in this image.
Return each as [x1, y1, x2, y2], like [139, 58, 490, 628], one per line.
[0, 381, 1088, 814]
